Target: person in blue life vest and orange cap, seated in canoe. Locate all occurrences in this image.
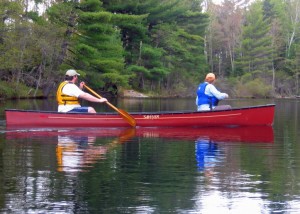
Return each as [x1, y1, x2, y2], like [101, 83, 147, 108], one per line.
[196, 73, 231, 111]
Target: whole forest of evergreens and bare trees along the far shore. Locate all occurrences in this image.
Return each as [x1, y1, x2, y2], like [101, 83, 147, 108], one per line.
[0, 0, 300, 98]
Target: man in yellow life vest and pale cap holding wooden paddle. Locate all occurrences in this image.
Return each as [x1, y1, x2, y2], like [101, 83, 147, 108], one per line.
[56, 69, 107, 113]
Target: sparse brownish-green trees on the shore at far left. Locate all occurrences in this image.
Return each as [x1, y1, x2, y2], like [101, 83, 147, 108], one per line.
[0, 2, 65, 96]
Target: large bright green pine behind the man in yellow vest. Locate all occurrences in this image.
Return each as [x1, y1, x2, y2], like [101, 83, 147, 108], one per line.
[64, 0, 128, 90]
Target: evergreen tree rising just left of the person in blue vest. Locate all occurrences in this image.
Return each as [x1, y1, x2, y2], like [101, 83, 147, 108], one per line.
[161, 4, 208, 93]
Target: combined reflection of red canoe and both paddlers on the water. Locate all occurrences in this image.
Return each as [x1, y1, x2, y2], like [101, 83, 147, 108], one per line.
[6, 126, 274, 171]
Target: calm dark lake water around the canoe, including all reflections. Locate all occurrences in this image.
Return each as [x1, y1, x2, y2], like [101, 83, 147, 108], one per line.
[0, 99, 300, 214]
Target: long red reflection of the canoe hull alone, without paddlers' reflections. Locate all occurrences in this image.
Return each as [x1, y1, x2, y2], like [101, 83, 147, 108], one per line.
[5, 126, 274, 144]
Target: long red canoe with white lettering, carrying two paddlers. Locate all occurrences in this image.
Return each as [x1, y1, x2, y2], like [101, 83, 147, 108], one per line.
[5, 104, 275, 127]
